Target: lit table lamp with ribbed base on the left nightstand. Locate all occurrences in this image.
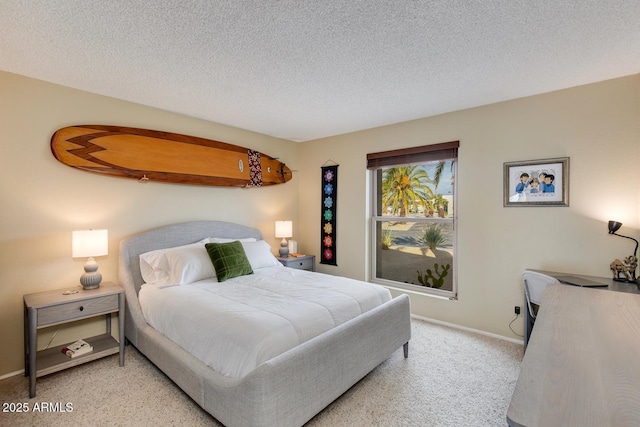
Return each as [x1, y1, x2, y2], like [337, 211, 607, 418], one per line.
[71, 230, 109, 289]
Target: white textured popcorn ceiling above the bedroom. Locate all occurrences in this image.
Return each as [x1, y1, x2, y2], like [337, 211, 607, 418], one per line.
[0, 0, 640, 141]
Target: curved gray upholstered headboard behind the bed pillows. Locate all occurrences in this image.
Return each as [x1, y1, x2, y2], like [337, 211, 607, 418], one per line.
[118, 221, 262, 294]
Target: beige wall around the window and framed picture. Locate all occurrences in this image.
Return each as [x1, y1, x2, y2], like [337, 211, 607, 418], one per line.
[297, 75, 640, 339]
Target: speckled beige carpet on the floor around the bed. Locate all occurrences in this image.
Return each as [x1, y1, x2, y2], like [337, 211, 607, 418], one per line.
[0, 319, 522, 427]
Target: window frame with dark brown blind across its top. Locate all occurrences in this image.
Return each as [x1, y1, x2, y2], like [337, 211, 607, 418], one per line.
[367, 141, 460, 300]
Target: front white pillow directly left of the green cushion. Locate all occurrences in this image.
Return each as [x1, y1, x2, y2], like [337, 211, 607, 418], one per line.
[140, 238, 210, 285]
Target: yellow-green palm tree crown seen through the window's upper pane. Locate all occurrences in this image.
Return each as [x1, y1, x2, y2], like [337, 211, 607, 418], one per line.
[382, 165, 433, 217]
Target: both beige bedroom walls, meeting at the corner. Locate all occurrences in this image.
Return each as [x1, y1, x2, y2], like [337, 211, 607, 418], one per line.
[0, 72, 640, 376]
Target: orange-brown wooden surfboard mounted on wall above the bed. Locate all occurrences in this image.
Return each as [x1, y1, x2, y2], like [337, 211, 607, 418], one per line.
[51, 125, 291, 187]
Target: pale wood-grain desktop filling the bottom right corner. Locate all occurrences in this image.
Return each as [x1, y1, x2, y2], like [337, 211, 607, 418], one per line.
[507, 285, 640, 427]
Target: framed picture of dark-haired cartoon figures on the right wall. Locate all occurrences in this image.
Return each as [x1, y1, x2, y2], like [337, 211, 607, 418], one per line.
[504, 157, 569, 206]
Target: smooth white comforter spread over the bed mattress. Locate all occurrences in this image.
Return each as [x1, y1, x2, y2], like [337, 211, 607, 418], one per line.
[139, 267, 391, 378]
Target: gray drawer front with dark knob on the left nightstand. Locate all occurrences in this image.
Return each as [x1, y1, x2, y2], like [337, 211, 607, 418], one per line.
[38, 295, 118, 326]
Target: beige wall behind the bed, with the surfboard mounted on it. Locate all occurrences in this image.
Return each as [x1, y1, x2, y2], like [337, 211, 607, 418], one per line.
[0, 72, 298, 376]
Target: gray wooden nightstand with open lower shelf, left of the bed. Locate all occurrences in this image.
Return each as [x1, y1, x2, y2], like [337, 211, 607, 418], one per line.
[24, 282, 125, 397]
